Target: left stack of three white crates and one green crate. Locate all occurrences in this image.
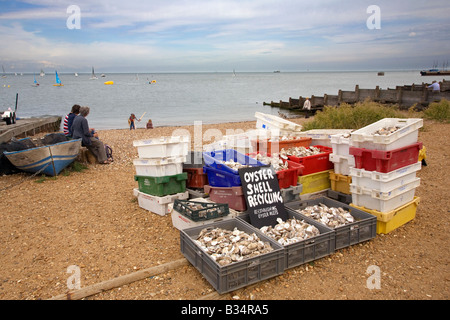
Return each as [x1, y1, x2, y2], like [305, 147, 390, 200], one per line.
[133, 136, 190, 216]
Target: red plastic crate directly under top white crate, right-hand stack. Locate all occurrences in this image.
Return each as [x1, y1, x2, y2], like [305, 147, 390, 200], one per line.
[349, 142, 422, 173]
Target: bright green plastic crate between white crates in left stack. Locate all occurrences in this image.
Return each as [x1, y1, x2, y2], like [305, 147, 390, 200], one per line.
[134, 172, 187, 197]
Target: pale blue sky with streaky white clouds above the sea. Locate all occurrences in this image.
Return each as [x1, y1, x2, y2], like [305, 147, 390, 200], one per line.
[0, 0, 450, 73]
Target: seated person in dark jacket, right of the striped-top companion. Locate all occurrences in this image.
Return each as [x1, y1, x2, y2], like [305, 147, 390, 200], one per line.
[72, 107, 109, 164]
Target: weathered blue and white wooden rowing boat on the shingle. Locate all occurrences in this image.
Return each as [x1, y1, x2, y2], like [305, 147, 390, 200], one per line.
[3, 138, 81, 176]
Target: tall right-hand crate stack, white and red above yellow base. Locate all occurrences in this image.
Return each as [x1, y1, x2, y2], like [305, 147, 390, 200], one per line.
[349, 118, 423, 233]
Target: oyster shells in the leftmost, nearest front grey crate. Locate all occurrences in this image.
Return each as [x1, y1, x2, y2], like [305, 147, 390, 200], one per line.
[195, 227, 274, 266]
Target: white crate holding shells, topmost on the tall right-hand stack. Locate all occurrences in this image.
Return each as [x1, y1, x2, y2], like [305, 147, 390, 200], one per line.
[350, 118, 423, 151]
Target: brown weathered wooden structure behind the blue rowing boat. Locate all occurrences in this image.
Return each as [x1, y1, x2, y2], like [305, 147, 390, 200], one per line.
[0, 116, 61, 143]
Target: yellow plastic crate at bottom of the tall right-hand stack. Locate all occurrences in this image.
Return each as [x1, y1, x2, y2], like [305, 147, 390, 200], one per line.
[350, 197, 420, 234]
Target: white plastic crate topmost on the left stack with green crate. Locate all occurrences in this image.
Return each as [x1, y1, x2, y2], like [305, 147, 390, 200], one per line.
[133, 136, 190, 159]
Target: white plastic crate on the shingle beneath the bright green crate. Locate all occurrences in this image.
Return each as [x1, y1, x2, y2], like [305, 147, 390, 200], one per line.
[133, 189, 189, 216]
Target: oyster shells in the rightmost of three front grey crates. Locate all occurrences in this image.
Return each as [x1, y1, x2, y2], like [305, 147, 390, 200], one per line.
[296, 203, 355, 229]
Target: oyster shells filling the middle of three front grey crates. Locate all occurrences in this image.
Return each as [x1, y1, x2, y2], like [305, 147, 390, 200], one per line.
[260, 217, 320, 246]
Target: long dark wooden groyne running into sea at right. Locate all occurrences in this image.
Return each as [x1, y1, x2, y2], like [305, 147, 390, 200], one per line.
[264, 80, 450, 111]
